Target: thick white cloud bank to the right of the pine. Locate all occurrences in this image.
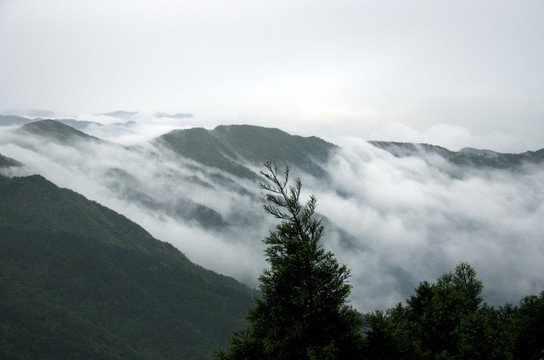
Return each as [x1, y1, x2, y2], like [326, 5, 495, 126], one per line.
[312, 141, 544, 309]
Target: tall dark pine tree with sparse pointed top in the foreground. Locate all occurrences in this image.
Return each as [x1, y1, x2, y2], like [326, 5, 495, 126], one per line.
[216, 163, 362, 360]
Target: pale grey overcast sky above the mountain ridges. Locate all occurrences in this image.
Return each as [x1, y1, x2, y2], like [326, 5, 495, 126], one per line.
[0, 0, 544, 152]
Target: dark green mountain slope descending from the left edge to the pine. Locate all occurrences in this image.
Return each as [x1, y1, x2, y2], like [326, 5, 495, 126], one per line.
[0, 175, 253, 359]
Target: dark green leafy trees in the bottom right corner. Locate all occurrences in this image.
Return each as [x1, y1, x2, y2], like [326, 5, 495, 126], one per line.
[364, 263, 544, 360]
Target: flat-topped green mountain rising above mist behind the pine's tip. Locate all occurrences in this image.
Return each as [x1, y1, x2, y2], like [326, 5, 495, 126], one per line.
[155, 125, 337, 180]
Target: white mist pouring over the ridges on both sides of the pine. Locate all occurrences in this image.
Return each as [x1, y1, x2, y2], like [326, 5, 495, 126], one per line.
[0, 119, 544, 312]
